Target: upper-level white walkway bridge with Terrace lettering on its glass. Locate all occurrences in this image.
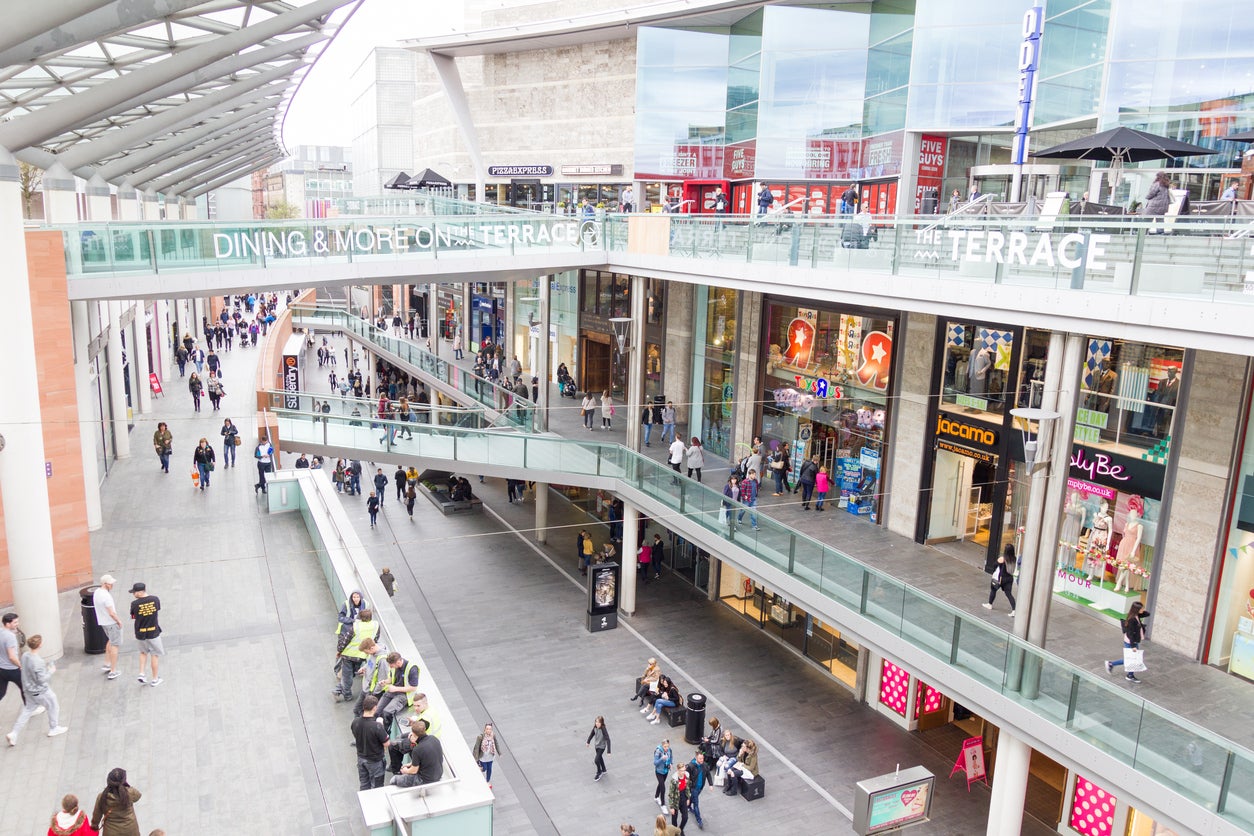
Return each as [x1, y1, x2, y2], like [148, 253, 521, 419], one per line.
[58, 199, 1254, 355]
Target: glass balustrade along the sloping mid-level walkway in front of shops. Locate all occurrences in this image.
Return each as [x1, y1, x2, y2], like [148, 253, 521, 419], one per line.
[275, 410, 1254, 827]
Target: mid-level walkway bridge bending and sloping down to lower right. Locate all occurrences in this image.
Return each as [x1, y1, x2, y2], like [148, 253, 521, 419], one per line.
[259, 392, 1254, 833]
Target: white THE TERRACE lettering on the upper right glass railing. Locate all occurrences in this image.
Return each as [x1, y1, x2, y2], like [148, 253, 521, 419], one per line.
[914, 229, 1110, 269]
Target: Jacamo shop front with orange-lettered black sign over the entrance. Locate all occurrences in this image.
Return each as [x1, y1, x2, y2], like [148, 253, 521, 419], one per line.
[915, 322, 1023, 565]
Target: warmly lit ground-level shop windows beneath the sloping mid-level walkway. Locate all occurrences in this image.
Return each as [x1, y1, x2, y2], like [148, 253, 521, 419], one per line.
[719, 563, 860, 689]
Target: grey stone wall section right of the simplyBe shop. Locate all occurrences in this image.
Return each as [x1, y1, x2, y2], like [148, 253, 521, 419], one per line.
[1152, 351, 1248, 656]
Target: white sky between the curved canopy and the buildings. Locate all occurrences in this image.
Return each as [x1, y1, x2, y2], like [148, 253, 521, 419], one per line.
[283, 0, 463, 148]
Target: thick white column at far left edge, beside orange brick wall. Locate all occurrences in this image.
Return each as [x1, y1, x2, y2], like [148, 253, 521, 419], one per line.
[0, 149, 63, 658]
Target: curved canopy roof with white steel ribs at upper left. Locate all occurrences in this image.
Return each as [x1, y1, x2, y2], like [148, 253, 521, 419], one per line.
[0, 0, 364, 197]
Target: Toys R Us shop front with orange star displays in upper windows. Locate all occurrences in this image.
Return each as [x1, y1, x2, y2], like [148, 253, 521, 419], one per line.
[757, 298, 897, 523]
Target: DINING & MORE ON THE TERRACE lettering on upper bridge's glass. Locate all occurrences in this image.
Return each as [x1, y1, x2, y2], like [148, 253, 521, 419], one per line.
[213, 221, 594, 258]
